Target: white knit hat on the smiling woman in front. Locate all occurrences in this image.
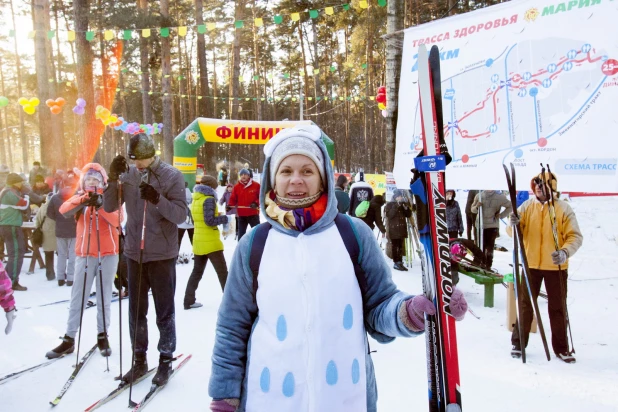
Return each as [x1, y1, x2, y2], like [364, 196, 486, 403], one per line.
[264, 131, 326, 185]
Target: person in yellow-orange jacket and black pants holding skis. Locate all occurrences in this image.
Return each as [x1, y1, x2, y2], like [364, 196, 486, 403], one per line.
[509, 173, 583, 363]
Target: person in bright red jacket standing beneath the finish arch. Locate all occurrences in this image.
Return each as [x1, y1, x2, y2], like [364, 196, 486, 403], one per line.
[225, 169, 260, 241]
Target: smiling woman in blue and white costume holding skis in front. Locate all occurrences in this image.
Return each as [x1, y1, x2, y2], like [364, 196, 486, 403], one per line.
[209, 125, 467, 412]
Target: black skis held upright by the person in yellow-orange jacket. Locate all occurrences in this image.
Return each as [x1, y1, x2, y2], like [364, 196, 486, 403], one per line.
[502, 163, 551, 361]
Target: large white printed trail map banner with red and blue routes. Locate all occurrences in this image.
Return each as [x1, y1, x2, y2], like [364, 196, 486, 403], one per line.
[394, 0, 618, 192]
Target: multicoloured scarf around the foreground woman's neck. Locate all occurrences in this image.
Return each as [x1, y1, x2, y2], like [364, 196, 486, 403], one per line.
[266, 190, 328, 232]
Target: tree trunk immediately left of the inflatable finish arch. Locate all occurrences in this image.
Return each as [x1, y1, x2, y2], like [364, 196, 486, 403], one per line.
[159, 0, 174, 164]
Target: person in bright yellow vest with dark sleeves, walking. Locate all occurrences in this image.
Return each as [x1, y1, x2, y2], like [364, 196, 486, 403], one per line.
[184, 175, 228, 310]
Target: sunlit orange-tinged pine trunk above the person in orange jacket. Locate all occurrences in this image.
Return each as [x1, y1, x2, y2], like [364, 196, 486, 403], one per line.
[73, 0, 95, 166]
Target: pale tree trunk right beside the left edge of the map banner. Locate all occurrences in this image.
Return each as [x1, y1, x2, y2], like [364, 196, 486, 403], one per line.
[385, 1, 404, 171]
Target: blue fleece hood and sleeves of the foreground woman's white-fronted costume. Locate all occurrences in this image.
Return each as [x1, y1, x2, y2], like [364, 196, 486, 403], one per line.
[209, 131, 422, 412]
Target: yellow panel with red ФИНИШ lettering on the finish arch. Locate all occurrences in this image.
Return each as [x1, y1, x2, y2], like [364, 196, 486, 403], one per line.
[198, 119, 311, 144]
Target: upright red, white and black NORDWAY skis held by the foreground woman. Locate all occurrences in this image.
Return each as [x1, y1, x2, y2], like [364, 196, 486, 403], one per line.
[410, 45, 461, 412]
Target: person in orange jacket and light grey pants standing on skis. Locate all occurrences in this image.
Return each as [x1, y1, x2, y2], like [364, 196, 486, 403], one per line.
[46, 163, 119, 359]
